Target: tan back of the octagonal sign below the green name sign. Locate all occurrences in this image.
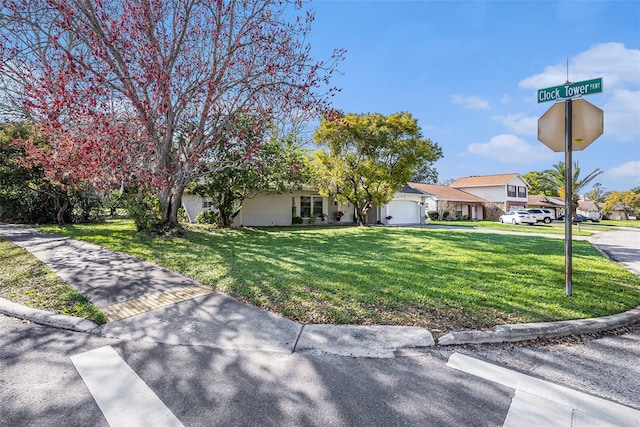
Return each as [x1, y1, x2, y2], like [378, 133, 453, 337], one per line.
[538, 99, 604, 153]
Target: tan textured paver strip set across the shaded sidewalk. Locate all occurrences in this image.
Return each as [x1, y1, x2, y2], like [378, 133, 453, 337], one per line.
[101, 286, 214, 322]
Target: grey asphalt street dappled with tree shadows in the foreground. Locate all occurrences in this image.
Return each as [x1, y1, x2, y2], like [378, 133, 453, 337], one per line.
[0, 316, 640, 426]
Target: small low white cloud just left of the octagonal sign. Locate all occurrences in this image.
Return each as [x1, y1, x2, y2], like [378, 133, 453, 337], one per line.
[467, 134, 555, 164]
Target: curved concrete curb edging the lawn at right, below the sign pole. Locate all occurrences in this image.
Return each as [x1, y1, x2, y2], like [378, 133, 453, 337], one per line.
[438, 306, 640, 345]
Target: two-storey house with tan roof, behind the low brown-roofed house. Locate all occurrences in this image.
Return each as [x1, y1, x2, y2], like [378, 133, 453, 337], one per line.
[449, 173, 529, 219]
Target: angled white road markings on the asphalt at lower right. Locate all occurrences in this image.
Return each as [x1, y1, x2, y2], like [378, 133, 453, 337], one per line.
[447, 353, 640, 427]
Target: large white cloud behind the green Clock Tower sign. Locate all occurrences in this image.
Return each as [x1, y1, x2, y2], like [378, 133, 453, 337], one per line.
[518, 42, 640, 92]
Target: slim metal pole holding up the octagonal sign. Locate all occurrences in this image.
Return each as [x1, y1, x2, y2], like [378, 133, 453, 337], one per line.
[564, 99, 573, 296]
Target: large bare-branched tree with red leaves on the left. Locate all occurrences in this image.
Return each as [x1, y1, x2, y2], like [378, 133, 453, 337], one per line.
[0, 0, 343, 226]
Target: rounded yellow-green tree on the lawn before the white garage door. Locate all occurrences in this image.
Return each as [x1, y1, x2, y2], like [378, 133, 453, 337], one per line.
[313, 112, 442, 224]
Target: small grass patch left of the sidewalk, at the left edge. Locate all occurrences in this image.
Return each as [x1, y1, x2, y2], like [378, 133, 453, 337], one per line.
[0, 239, 106, 324]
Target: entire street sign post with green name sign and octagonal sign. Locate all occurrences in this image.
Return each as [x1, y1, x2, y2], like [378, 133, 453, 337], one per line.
[538, 78, 604, 296]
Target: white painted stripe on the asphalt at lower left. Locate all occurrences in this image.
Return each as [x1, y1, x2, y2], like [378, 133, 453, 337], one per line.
[71, 346, 182, 427]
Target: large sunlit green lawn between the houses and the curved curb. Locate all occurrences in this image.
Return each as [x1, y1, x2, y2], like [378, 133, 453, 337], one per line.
[36, 220, 640, 331]
